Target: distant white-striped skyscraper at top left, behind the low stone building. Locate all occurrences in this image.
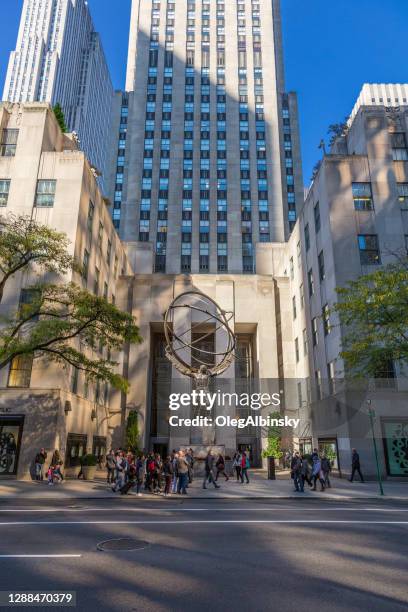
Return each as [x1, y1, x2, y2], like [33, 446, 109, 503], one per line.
[3, 0, 113, 189]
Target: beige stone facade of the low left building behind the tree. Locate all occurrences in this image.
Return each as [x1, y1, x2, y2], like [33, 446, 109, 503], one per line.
[0, 103, 130, 478]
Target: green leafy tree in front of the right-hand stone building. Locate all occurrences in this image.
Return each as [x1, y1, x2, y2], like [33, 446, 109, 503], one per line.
[333, 259, 408, 378]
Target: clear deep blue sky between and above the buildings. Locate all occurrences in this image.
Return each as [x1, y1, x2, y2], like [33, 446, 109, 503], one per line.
[0, 0, 408, 184]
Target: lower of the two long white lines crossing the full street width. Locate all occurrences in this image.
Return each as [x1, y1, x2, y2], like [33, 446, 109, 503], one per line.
[0, 519, 408, 527]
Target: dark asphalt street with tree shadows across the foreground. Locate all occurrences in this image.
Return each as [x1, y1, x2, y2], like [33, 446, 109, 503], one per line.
[0, 497, 408, 612]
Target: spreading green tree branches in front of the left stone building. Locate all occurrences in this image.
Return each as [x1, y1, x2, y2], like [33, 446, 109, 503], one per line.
[0, 216, 141, 391]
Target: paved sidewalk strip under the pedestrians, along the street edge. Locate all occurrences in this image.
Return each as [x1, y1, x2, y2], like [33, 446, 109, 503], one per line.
[0, 470, 408, 504]
